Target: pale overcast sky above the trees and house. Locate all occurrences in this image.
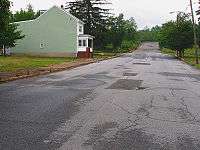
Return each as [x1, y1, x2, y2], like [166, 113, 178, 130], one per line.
[11, 0, 198, 29]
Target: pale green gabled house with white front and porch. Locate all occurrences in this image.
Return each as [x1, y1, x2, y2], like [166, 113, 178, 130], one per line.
[11, 6, 93, 57]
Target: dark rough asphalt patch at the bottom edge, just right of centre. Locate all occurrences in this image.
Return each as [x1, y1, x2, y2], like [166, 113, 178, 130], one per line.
[83, 122, 162, 150]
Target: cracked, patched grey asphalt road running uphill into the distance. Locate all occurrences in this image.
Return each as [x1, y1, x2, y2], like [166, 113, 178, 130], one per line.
[0, 43, 200, 150]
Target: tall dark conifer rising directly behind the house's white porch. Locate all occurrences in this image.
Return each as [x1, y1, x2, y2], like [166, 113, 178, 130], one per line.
[66, 0, 110, 47]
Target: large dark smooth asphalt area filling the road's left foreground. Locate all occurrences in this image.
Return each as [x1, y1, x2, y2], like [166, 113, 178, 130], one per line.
[0, 87, 92, 150]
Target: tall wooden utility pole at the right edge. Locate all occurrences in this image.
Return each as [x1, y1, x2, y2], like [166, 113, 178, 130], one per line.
[190, 0, 199, 64]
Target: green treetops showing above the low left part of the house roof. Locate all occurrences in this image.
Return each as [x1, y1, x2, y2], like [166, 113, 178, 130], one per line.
[13, 4, 40, 22]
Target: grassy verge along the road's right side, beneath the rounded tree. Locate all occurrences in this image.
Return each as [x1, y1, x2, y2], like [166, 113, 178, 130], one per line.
[161, 48, 200, 69]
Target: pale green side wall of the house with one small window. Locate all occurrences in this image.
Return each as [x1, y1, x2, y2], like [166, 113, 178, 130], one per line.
[12, 7, 77, 54]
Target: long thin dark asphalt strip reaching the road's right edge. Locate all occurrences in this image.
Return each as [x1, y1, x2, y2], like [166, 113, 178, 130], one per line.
[158, 72, 200, 81]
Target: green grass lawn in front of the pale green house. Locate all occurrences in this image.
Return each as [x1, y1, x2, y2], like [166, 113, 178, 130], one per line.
[0, 56, 74, 72]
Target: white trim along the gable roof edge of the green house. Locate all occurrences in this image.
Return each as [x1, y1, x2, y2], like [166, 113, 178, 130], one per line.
[14, 6, 85, 24]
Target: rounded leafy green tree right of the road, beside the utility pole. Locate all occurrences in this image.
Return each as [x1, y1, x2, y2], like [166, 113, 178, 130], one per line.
[159, 13, 194, 57]
